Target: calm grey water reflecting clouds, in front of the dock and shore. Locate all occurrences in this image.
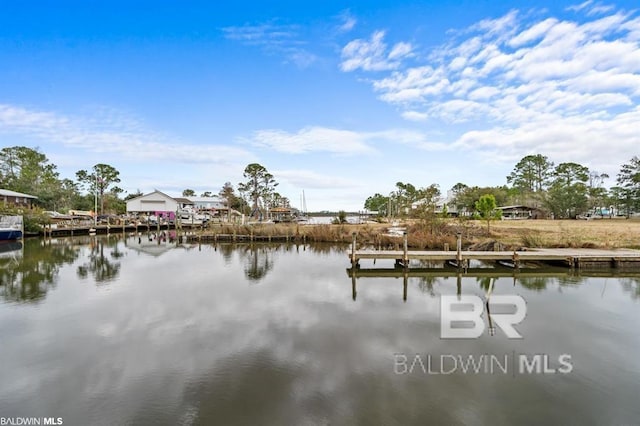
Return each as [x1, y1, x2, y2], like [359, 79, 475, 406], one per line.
[0, 236, 640, 425]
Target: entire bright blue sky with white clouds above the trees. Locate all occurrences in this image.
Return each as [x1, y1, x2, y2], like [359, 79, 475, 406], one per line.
[0, 0, 640, 210]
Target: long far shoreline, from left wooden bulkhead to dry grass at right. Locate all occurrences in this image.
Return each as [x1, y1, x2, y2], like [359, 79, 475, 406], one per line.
[33, 219, 640, 250]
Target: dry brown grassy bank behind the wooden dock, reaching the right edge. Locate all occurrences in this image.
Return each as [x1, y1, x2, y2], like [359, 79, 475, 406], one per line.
[198, 219, 640, 250]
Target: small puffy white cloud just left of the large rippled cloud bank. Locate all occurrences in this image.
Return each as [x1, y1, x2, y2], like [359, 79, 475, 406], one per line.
[340, 31, 413, 72]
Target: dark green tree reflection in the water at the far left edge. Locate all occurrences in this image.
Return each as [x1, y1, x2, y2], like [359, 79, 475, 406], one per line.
[0, 239, 80, 303]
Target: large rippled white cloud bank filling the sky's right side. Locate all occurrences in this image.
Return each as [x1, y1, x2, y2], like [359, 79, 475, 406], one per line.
[342, 5, 640, 173]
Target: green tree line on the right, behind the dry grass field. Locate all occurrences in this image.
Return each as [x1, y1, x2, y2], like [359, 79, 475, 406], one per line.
[364, 154, 640, 218]
